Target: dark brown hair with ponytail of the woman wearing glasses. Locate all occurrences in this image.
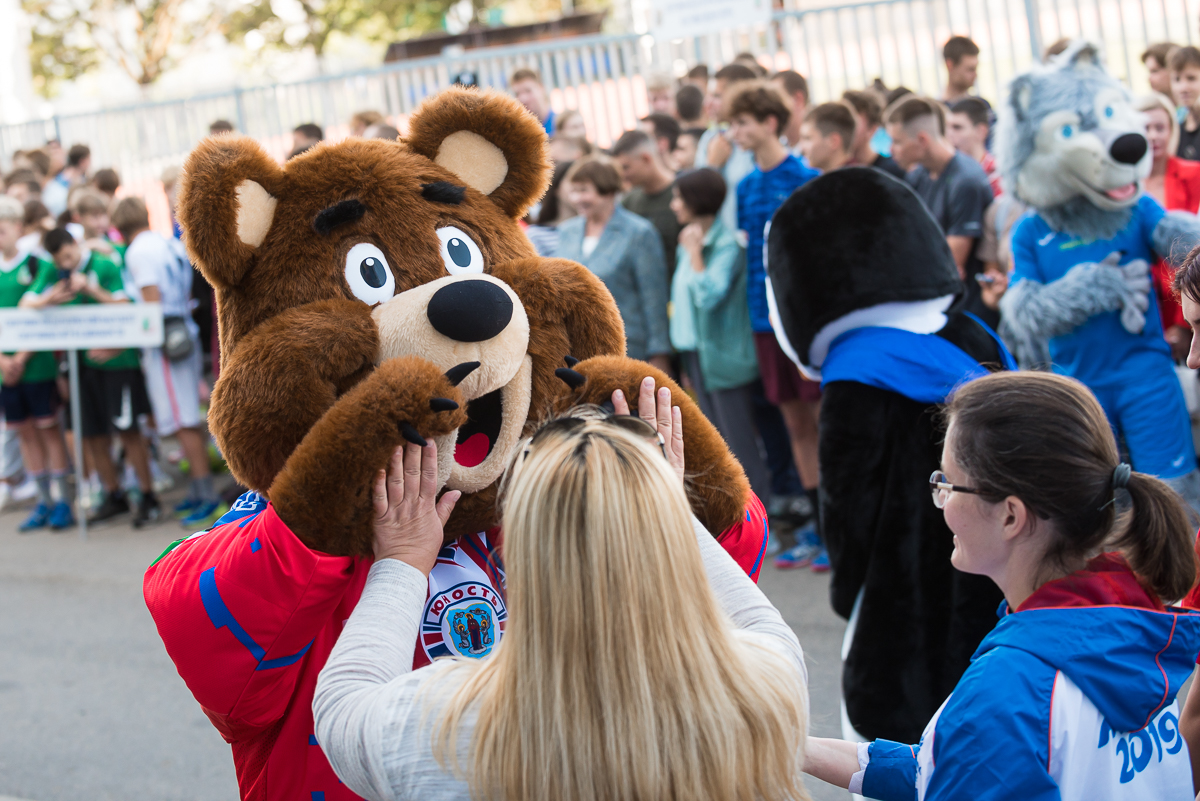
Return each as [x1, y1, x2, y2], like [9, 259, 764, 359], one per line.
[944, 372, 1196, 602]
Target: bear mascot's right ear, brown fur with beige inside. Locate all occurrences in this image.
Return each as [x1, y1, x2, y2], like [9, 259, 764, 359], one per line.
[404, 88, 551, 219]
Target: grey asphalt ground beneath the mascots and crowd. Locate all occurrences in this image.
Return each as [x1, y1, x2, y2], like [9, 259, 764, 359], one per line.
[0, 492, 864, 801]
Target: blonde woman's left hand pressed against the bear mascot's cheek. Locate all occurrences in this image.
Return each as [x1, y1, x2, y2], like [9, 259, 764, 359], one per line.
[372, 441, 462, 576]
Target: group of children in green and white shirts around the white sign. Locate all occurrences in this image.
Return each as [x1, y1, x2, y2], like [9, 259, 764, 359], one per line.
[0, 143, 225, 532]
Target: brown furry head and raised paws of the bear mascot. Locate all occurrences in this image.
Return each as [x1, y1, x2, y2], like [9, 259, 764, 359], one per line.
[180, 89, 749, 555]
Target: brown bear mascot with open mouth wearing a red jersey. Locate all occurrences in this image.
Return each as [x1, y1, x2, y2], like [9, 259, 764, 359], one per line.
[144, 89, 767, 801]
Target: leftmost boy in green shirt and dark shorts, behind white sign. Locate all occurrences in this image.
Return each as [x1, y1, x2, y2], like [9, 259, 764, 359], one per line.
[0, 197, 74, 532]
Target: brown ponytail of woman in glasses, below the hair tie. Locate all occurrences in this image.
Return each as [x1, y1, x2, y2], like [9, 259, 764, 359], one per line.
[1112, 472, 1196, 602]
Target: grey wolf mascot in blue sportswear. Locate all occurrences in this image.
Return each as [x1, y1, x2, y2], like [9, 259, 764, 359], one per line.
[997, 41, 1200, 510]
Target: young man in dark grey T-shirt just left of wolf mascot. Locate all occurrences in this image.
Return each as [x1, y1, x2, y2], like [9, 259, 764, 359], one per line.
[887, 95, 1000, 327]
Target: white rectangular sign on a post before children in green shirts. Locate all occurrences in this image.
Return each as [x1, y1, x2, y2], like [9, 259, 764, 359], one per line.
[0, 303, 162, 353]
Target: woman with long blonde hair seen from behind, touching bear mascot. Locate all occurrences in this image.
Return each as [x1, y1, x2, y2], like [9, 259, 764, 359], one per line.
[313, 398, 809, 801]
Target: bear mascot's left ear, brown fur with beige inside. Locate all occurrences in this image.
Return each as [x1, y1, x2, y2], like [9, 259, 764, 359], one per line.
[179, 137, 286, 288]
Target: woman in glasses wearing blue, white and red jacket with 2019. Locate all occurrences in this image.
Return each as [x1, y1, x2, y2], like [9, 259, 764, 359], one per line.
[805, 373, 1200, 801]
